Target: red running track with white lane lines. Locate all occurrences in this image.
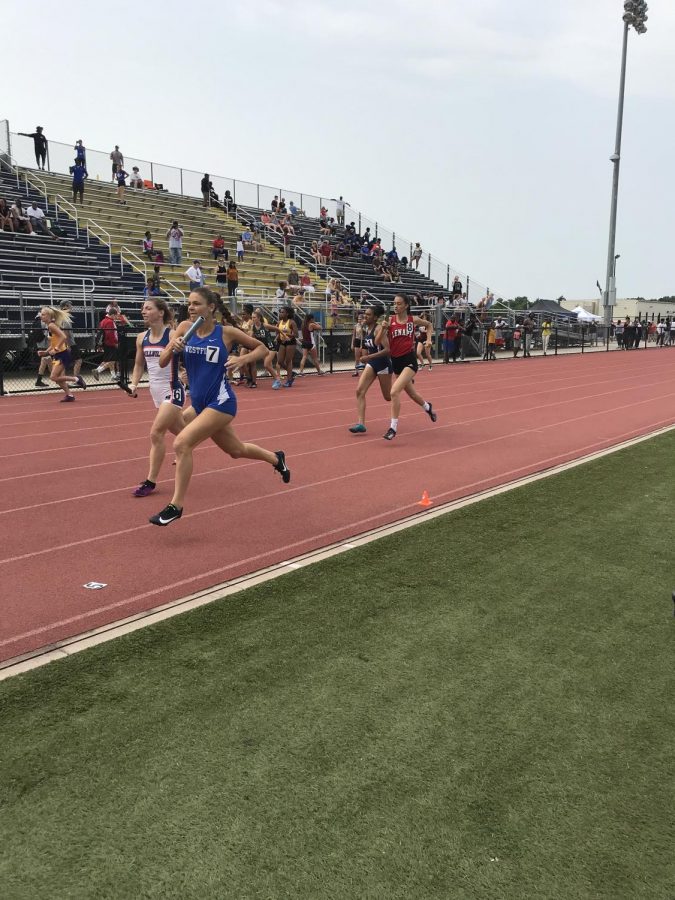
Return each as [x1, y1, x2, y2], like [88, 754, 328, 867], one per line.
[0, 350, 675, 660]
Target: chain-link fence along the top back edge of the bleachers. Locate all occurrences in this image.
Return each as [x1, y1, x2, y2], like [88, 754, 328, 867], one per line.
[9, 132, 499, 303]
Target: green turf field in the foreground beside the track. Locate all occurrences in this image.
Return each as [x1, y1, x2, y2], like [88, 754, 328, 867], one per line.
[0, 433, 675, 900]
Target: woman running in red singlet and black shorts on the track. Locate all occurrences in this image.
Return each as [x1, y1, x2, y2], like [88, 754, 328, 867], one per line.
[384, 294, 436, 441]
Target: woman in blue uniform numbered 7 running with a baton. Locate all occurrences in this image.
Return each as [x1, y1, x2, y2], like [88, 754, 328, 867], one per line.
[150, 288, 291, 525]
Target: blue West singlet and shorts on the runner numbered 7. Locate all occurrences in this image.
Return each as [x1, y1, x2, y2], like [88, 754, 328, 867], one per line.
[183, 325, 237, 416]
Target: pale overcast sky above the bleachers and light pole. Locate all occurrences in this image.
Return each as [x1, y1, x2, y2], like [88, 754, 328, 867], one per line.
[0, 0, 675, 299]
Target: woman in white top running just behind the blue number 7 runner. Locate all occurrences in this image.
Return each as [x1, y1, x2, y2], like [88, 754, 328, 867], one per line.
[130, 297, 185, 497]
